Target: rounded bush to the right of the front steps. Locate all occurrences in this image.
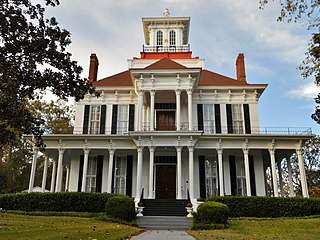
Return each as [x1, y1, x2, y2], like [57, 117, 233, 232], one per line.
[194, 202, 229, 224]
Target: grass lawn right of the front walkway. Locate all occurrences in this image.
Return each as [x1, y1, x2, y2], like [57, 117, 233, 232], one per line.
[189, 218, 320, 240]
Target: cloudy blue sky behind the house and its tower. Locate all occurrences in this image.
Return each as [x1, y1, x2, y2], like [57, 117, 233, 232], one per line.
[47, 0, 320, 134]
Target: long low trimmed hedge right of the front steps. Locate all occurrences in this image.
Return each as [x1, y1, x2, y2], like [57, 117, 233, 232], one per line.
[206, 196, 320, 218]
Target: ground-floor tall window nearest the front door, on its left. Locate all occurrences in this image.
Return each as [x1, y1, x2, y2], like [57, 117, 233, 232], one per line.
[114, 156, 127, 195]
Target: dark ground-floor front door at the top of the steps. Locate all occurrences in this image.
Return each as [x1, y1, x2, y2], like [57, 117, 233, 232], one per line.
[156, 165, 176, 199]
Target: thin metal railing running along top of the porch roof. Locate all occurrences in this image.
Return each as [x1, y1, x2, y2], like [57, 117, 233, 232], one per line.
[50, 125, 312, 135]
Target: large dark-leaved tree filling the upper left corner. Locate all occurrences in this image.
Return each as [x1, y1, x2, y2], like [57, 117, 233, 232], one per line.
[0, 0, 94, 147]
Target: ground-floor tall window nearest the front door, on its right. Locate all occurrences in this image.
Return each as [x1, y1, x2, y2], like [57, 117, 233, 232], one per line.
[205, 159, 218, 197]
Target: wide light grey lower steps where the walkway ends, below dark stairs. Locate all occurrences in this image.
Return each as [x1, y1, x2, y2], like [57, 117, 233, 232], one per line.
[137, 216, 192, 231]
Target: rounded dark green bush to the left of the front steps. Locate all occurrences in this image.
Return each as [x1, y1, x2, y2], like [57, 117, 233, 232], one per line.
[106, 196, 136, 222]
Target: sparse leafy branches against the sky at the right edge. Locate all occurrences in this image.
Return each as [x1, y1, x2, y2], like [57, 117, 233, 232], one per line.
[259, 0, 320, 124]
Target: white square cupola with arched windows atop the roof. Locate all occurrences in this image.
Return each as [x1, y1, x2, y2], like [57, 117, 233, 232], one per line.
[142, 8, 190, 52]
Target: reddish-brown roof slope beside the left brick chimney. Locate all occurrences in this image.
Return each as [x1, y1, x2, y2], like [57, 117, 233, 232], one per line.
[93, 70, 133, 87]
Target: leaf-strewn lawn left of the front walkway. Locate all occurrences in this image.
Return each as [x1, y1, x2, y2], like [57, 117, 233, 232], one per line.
[0, 213, 141, 240]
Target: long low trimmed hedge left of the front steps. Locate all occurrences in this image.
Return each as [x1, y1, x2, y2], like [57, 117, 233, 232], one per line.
[0, 192, 114, 212]
